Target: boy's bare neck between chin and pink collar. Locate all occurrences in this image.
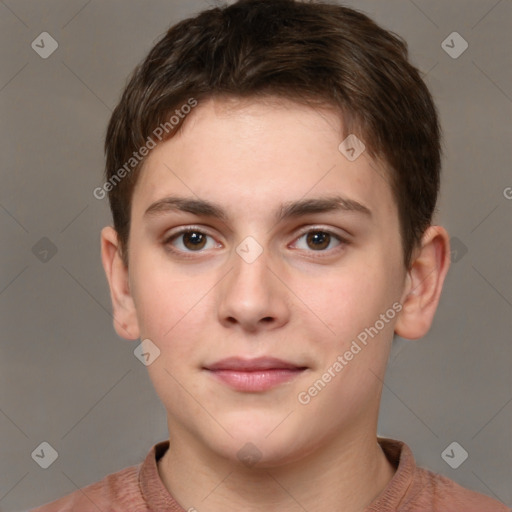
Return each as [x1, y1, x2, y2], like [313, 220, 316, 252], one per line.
[158, 429, 395, 512]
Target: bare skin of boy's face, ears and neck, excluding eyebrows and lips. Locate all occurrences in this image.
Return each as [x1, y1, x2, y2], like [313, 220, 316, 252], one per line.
[101, 99, 450, 512]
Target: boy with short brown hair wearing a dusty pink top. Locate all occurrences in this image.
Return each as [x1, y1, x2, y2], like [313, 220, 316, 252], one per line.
[31, 0, 508, 512]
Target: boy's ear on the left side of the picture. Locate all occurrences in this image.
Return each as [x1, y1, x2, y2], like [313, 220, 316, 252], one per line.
[101, 226, 140, 340]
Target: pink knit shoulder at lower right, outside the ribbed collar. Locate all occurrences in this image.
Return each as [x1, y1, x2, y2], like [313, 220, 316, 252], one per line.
[410, 468, 511, 512]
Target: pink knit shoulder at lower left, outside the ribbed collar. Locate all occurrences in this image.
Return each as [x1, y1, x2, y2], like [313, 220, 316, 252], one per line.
[30, 465, 144, 512]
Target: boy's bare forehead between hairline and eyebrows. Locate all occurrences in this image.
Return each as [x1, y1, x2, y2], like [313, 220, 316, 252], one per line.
[133, 99, 395, 224]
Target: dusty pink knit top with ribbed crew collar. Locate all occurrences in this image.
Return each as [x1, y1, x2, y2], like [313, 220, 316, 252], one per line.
[31, 438, 512, 512]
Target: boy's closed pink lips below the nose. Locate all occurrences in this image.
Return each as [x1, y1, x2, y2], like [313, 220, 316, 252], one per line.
[203, 357, 308, 393]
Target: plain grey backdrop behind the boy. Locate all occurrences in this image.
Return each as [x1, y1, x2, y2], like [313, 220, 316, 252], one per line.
[0, 0, 512, 512]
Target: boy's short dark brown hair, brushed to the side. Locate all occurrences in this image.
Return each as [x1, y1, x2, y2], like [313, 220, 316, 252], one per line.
[105, 0, 441, 268]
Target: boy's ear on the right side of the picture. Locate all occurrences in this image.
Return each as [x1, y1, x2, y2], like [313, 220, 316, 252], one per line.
[395, 226, 450, 340]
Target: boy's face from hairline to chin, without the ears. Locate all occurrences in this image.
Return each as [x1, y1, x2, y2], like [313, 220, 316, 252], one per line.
[108, 100, 412, 466]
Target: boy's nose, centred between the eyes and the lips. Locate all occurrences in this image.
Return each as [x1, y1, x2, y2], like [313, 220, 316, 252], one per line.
[217, 240, 291, 332]
